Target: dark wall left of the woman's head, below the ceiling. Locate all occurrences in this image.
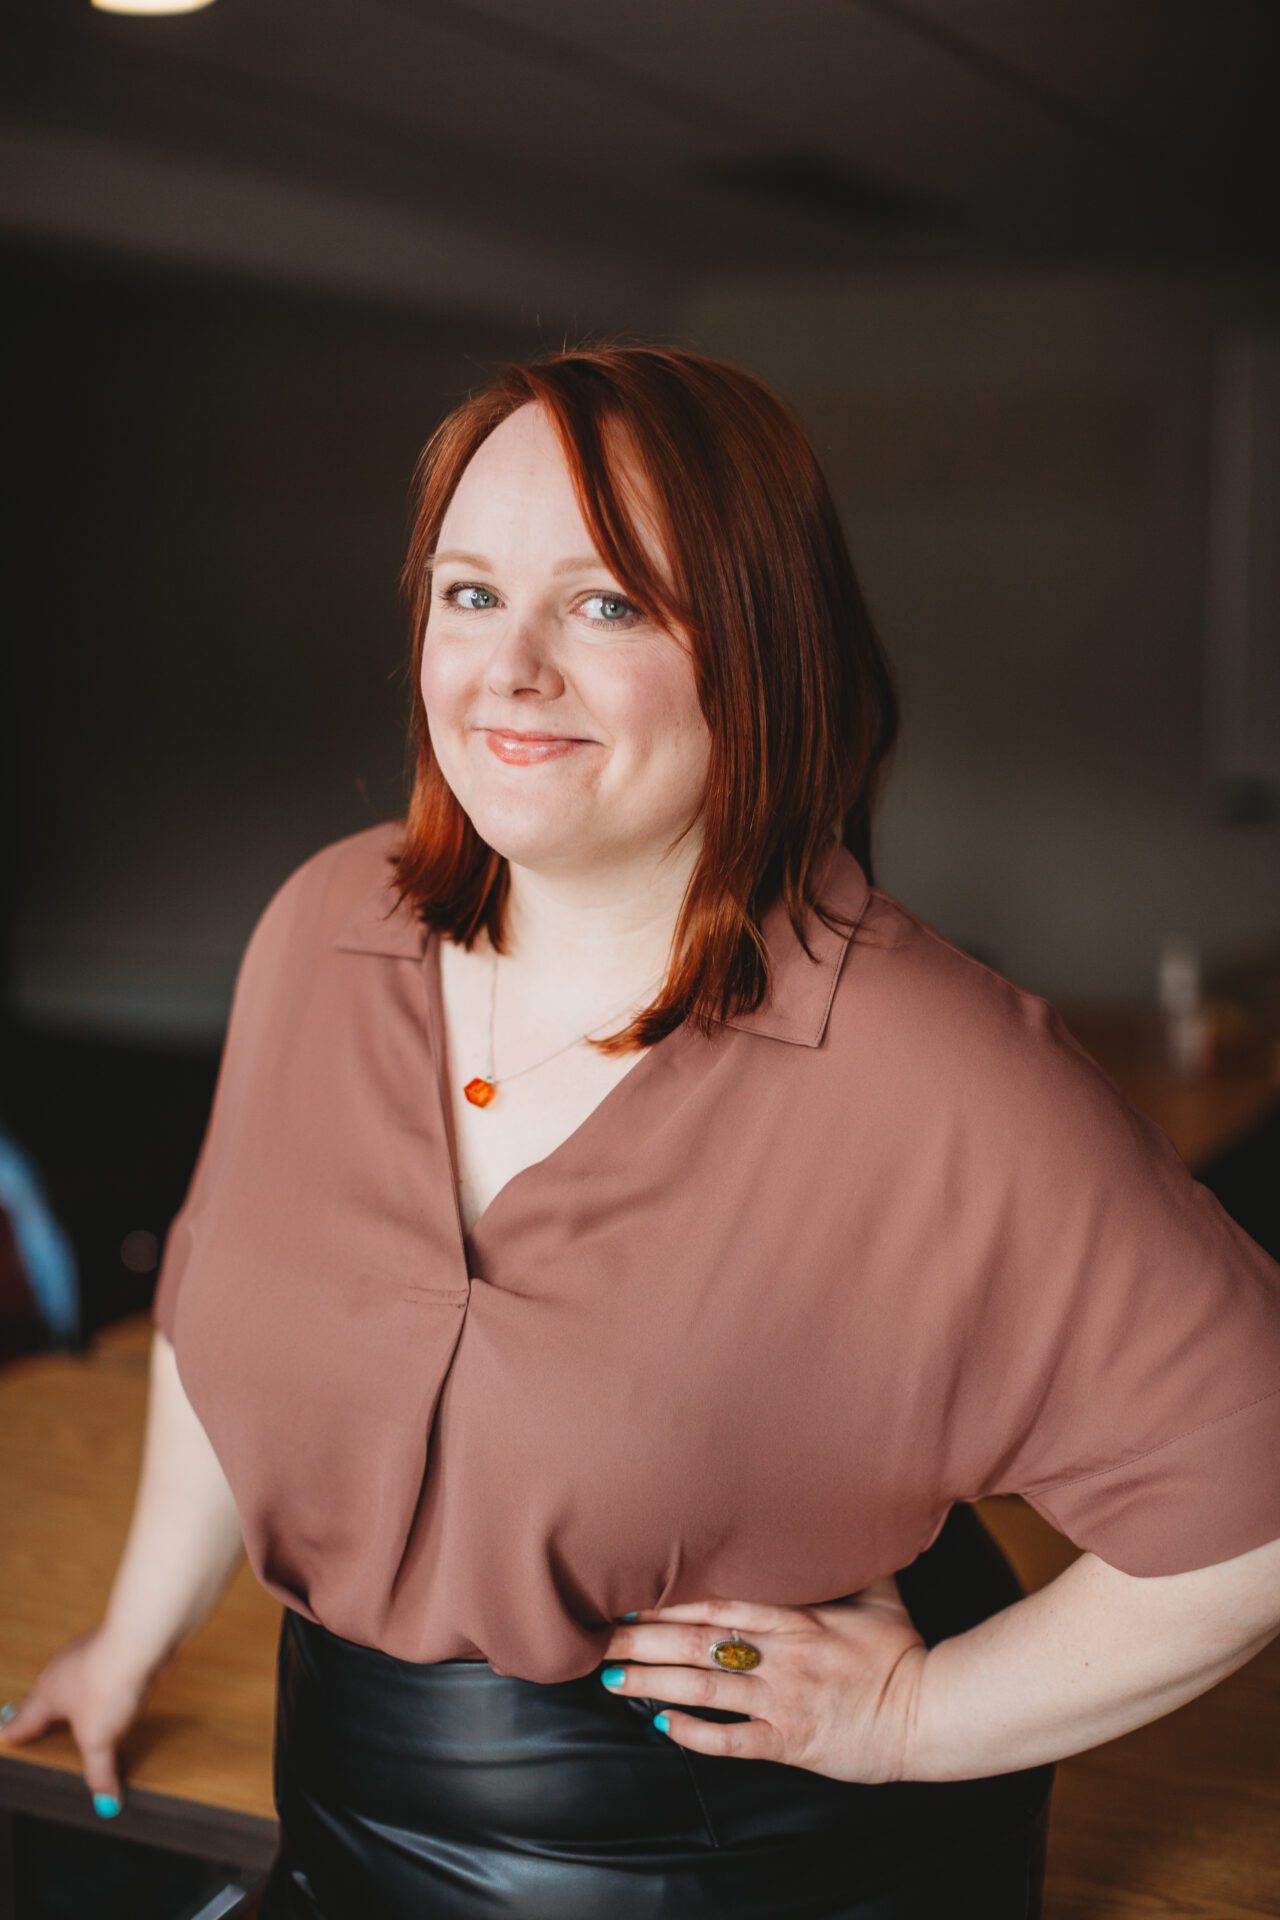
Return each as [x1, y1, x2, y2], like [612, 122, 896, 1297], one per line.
[0, 252, 551, 1338]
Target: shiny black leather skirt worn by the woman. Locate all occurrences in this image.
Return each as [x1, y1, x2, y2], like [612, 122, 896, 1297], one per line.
[259, 1507, 1054, 1920]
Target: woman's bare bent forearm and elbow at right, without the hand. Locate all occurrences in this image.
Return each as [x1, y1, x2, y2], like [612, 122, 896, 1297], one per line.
[904, 1540, 1280, 1780]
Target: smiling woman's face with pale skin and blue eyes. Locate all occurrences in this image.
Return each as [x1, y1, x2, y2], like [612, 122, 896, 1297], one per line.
[422, 405, 710, 887]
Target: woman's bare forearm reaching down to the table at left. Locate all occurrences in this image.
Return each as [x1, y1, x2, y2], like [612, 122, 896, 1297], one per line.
[100, 1329, 244, 1674]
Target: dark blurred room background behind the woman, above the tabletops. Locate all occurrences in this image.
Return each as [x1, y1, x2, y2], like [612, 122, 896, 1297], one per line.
[0, 0, 1280, 1904]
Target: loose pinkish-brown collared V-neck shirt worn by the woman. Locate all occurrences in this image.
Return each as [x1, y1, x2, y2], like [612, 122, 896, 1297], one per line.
[154, 822, 1280, 1680]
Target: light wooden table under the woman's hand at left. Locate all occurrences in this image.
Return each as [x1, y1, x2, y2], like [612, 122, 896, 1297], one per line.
[0, 1315, 280, 1914]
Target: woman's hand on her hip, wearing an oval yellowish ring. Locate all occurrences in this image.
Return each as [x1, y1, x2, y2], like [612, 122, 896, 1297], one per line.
[604, 1574, 927, 1786]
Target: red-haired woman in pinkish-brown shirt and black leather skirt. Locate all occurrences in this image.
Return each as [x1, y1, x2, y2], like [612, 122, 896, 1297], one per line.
[10, 344, 1280, 1920]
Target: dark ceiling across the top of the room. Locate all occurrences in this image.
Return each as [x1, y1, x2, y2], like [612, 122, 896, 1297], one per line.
[0, 0, 1280, 324]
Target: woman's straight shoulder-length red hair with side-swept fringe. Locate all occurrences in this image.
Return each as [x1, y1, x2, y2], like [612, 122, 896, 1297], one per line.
[391, 338, 898, 1054]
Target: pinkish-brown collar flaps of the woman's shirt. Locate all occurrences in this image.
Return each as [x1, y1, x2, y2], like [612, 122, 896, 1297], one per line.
[334, 841, 871, 1046]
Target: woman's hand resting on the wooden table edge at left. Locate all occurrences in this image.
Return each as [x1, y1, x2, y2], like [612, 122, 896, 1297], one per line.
[0, 1626, 167, 1818]
